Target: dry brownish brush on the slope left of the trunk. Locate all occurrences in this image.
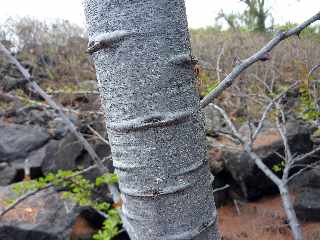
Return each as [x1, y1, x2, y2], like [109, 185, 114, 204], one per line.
[0, 17, 95, 87]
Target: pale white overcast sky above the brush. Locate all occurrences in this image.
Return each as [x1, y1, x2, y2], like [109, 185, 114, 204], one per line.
[0, 0, 320, 28]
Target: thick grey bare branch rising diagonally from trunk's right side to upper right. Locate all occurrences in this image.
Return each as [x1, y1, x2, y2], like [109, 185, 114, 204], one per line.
[201, 12, 320, 108]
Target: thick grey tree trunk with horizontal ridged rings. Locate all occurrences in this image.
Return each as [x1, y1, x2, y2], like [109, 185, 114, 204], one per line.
[84, 0, 219, 240]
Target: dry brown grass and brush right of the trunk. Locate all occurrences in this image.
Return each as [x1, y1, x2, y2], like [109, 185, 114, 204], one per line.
[191, 30, 320, 118]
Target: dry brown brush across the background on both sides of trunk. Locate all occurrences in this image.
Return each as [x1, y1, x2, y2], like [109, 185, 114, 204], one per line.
[0, 18, 320, 95]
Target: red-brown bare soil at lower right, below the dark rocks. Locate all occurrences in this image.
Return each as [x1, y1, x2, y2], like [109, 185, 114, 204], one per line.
[218, 197, 320, 240]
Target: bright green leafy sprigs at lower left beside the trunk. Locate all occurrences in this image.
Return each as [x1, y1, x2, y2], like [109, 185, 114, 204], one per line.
[5, 170, 121, 240]
